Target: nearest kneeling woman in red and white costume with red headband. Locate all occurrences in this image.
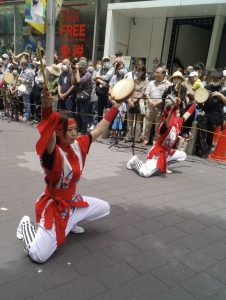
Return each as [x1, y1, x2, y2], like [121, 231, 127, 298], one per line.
[17, 91, 119, 263]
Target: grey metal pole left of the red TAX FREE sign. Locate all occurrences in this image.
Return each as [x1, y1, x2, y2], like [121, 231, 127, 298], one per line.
[46, 0, 56, 65]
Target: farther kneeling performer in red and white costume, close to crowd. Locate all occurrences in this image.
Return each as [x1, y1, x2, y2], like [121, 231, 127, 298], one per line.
[127, 98, 195, 177]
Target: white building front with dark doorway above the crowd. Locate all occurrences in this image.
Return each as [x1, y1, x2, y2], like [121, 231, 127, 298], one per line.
[104, 0, 226, 72]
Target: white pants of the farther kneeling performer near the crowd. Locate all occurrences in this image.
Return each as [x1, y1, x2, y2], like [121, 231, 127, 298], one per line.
[132, 150, 186, 177]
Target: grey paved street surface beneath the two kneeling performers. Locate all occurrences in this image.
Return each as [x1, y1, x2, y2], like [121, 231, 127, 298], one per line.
[0, 120, 226, 300]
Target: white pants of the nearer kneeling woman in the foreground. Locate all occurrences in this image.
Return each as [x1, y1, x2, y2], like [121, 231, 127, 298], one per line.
[28, 196, 110, 263]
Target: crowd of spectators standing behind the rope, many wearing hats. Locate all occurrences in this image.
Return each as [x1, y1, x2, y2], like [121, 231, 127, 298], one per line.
[0, 49, 226, 157]
